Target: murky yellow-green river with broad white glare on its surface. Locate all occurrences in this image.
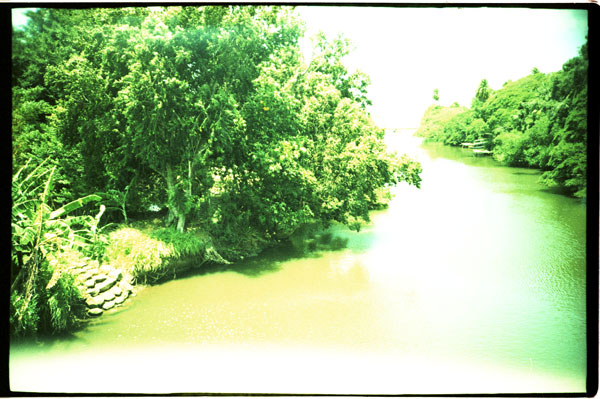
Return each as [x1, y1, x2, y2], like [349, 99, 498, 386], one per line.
[9, 133, 586, 394]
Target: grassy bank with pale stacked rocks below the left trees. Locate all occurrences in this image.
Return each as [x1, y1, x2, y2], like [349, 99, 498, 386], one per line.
[64, 219, 231, 317]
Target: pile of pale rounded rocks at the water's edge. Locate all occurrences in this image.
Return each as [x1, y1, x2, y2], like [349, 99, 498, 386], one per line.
[69, 261, 135, 316]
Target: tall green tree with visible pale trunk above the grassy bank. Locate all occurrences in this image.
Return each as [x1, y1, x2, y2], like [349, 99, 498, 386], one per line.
[119, 8, 308, 230]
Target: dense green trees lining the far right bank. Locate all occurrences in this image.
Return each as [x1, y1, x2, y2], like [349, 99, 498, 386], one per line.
[417, 44, 588, 197]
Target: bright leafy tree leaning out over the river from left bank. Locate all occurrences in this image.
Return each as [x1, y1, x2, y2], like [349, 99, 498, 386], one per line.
[211, 29, 420, 244]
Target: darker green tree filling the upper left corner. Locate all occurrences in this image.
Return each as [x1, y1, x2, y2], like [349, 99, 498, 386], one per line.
[13, 8, 148, 212]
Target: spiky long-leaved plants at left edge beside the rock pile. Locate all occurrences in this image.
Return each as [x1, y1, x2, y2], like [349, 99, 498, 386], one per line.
[10, 164, 104, 334]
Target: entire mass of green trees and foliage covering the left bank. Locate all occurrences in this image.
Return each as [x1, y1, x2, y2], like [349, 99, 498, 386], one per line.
[12, 6, 420, 330]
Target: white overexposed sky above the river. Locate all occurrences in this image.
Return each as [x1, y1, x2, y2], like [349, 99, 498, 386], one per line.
[297, 6, 588, 127]
